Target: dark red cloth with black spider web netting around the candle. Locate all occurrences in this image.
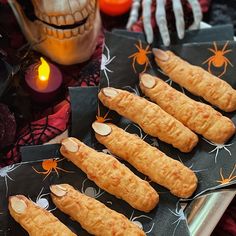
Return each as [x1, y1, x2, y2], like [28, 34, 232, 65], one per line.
[0, 2, 104, 168]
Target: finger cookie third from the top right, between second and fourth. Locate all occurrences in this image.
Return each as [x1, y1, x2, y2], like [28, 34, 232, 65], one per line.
[98, 87, 198, 152]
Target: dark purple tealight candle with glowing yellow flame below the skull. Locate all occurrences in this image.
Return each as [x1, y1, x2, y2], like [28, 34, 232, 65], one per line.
[25, 57, 62, 103]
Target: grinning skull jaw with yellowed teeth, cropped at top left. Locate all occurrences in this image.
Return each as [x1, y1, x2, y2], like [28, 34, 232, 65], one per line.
[8, 0, 101, 65]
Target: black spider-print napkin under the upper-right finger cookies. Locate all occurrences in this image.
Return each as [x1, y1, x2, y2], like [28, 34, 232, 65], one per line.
[97, 33, 236, 197]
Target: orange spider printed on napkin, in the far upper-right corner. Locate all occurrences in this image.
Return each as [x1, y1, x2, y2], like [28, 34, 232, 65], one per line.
[202, 41, 233, 77]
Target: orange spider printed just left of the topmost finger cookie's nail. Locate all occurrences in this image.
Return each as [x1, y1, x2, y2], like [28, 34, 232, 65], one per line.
[129, 40, 151, 73]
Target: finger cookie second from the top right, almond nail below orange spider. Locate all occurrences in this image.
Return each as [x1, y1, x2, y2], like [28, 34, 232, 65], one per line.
[140, 74, 235, 144]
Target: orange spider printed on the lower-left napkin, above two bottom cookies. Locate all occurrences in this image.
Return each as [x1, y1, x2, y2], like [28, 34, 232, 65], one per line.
[32, 158, 73, 180]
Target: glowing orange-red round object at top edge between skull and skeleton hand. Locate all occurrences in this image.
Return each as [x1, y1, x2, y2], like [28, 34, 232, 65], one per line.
[99, 0, 132, 16]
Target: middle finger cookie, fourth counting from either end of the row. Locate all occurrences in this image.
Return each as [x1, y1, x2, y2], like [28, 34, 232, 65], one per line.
[93, 122, 198, 198]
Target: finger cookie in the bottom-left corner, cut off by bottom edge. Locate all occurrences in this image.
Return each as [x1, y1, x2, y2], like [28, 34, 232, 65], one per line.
[8, 195, 76, 236]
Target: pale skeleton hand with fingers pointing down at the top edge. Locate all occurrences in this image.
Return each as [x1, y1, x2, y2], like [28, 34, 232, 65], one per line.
[127, 0, 202, 46]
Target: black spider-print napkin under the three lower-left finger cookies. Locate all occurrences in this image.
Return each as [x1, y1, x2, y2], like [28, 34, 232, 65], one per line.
[0, 145, 189, 236]
